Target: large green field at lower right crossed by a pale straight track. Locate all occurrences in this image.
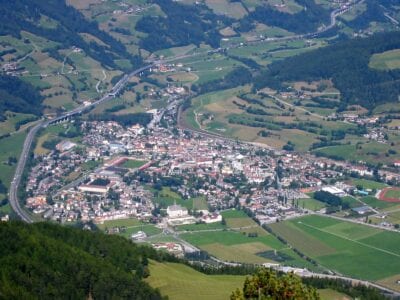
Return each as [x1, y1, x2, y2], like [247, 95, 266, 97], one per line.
[270, 216, 400, 281]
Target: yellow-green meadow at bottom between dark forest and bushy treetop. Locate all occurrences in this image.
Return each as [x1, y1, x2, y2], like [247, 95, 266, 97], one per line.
[146, 261, 245, 300]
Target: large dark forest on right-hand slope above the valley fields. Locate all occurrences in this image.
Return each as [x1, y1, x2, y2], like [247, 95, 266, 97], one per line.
[254, 32, 400, 109]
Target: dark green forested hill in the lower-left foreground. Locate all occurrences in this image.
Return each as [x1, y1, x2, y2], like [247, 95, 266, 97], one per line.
[0, 222, 175, 299]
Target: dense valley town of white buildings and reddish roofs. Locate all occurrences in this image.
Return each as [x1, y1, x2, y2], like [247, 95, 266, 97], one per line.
[26, 108, 400, 255]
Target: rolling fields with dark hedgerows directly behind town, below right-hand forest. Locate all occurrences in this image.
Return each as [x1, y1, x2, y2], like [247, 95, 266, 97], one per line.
[182, 86, 356, 152]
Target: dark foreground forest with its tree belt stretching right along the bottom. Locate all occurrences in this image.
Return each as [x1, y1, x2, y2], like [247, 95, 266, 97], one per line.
[0, 221, 385, 300]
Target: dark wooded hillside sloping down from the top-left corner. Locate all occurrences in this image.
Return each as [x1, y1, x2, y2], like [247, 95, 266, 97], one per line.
[0, 0, 138, 67]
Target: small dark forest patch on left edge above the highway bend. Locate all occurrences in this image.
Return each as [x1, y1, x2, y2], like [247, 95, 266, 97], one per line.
[0, 75, 43, 121]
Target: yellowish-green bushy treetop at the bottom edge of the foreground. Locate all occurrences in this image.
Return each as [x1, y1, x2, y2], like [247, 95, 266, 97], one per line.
[231, 269, 320, 300]
